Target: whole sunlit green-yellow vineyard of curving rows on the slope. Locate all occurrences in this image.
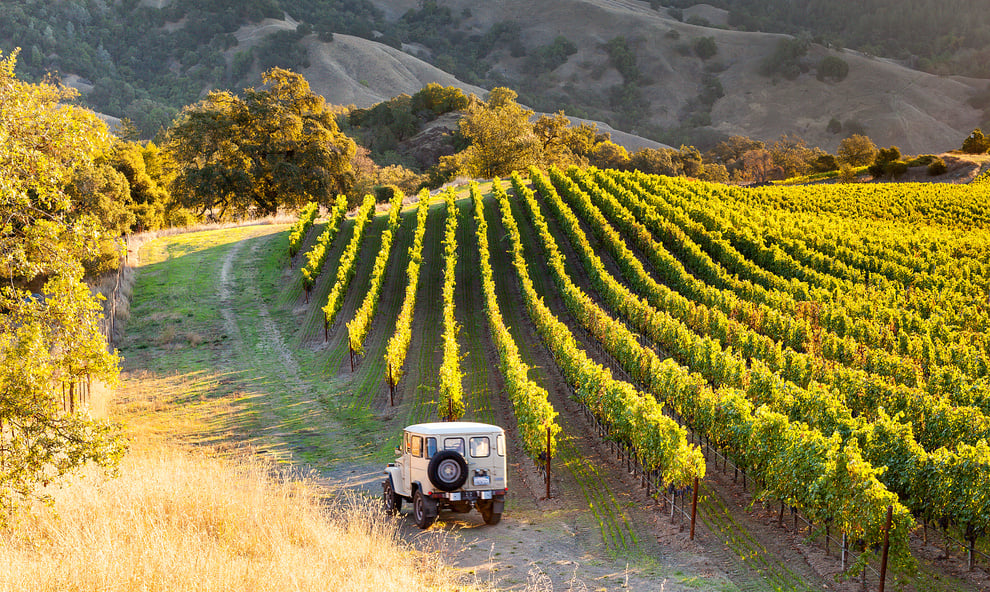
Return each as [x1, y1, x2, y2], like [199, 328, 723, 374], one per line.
[287, 168, 990, 589]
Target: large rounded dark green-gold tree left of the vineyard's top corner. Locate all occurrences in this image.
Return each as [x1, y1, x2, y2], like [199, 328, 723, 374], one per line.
[164, 68, 356, 220]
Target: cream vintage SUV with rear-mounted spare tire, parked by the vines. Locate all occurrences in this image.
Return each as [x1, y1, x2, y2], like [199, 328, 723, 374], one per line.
[382, 421, 508, 528]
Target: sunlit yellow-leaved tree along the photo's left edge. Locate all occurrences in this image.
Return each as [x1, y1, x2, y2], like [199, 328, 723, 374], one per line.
[0, 53, 121, 520]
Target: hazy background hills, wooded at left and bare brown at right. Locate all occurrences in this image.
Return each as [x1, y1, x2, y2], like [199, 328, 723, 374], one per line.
[0, 0, 990, 153]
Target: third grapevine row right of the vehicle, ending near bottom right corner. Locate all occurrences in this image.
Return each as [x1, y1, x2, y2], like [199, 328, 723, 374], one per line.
[513, 175, 913, 566]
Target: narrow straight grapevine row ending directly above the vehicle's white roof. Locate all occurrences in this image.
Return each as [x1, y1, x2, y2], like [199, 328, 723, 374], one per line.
[437, 191, 464, 421]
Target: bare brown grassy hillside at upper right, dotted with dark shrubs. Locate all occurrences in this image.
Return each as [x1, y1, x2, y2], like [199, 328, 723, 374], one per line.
[368, 0, 987, 153]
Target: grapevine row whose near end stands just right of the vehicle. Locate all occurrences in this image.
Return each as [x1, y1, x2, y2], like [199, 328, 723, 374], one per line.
[471, 183, 560, 459]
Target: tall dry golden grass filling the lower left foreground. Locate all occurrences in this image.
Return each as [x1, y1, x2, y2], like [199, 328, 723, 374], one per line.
[0, 444, 473, 592]
